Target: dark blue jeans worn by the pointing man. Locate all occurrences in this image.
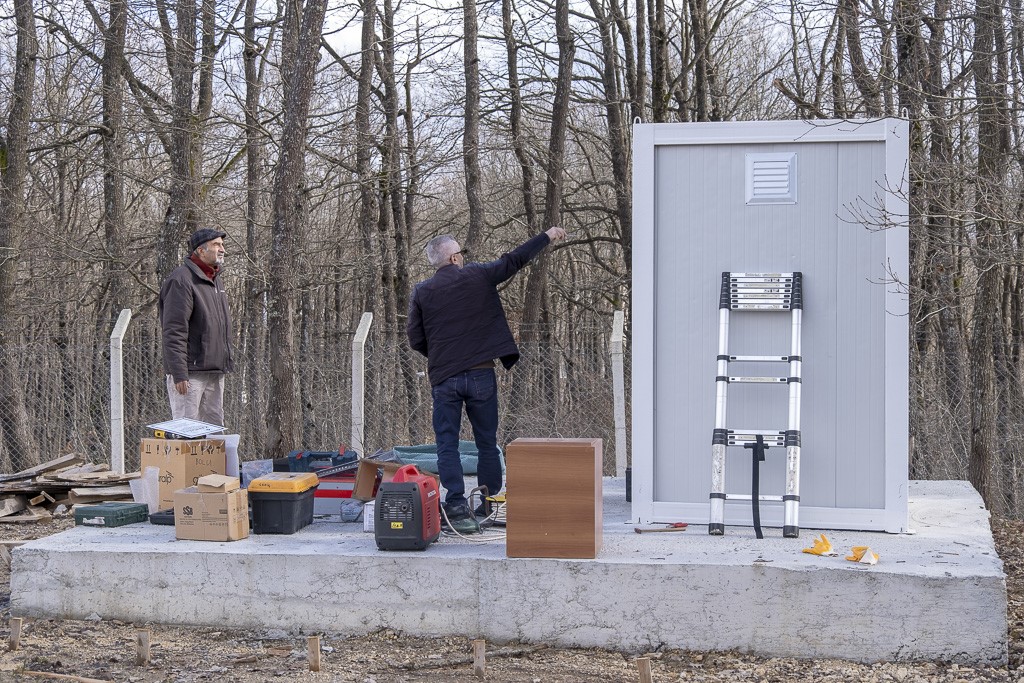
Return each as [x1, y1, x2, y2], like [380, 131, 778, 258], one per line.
[431, 368, 502, 506]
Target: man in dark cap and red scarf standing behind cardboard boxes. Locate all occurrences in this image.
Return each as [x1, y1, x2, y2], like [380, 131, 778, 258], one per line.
[159, 227, 231, 426]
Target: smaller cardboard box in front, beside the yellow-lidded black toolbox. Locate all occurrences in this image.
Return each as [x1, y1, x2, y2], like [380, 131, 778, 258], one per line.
[174, 474, 249, 541]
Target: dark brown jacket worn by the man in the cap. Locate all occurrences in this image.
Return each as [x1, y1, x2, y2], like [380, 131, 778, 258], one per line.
[159, 259, 231, 382]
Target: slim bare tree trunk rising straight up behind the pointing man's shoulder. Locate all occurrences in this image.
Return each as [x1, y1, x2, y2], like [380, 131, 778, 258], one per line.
[462, 0, 484, 252]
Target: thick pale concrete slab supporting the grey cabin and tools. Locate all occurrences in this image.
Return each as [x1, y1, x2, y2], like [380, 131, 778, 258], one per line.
[11, 479, 1008, 665]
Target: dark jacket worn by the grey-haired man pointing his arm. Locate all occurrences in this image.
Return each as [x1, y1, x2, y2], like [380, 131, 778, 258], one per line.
[406, 232, 551, 386]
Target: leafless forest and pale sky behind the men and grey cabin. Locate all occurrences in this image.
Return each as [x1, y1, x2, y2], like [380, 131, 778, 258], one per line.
[0, 0, 1024, 517]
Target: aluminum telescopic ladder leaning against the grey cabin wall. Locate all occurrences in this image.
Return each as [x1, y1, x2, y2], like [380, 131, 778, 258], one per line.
[708, 272, 804, 539]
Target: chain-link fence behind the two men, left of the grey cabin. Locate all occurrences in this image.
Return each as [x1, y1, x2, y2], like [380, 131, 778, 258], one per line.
[0, 321, 630, 474]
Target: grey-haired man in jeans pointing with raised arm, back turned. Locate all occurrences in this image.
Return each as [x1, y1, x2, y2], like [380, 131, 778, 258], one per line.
[407, 227, 565, 533]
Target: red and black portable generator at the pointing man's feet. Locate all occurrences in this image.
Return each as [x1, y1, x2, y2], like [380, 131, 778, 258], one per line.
[374, 465, 441, 550]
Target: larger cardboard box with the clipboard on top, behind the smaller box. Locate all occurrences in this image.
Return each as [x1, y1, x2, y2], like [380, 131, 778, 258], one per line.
[139, 438, 226, 510]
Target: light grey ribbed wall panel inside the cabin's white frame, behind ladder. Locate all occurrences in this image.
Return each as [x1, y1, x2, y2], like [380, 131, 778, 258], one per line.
[653, 142, 885, 509]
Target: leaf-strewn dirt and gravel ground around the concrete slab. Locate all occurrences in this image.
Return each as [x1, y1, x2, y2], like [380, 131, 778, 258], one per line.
[0, 517, 1024, 683]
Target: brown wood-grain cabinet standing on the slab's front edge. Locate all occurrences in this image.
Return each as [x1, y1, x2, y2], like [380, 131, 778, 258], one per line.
[505, 438, 603, 559]
